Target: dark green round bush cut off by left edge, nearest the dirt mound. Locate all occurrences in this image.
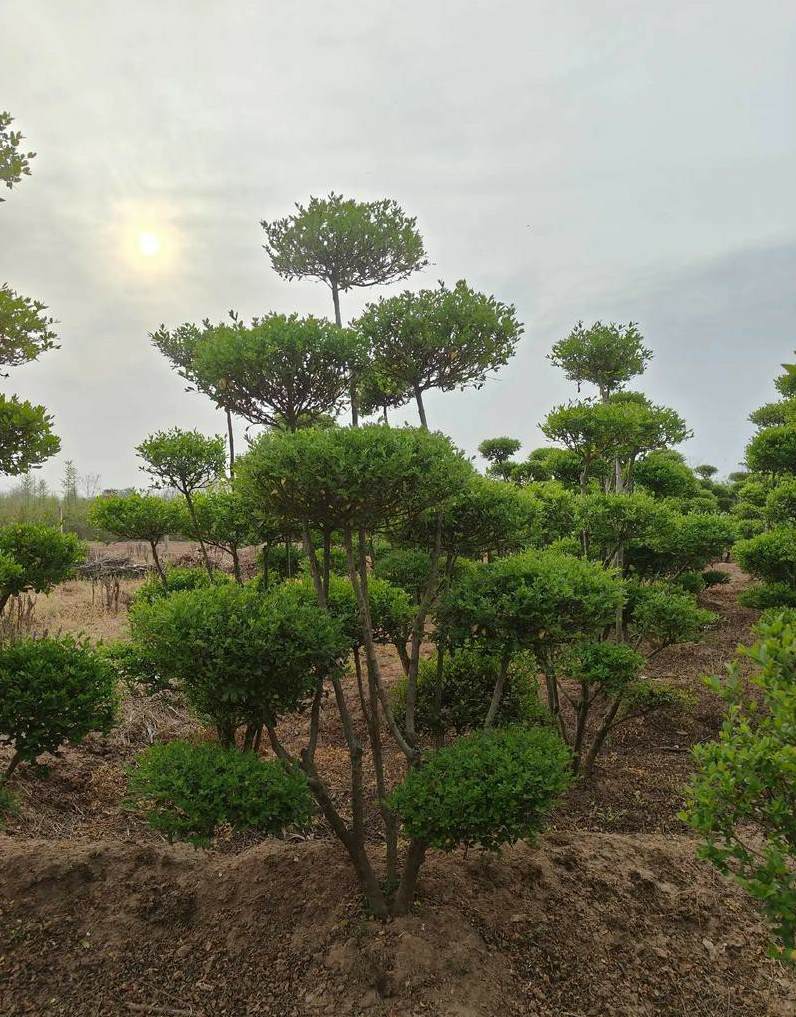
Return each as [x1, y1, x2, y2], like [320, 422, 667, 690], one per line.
[0, 636, 117, 772]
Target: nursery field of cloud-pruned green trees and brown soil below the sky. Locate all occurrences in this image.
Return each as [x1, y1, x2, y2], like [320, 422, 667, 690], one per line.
[0, 129, 796, 1017]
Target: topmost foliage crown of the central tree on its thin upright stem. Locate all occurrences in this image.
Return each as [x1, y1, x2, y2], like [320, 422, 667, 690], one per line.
[260, 192, 428, 426]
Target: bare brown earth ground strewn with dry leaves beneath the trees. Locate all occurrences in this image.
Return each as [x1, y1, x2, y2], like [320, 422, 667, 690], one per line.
[0, 548, 796, 1017]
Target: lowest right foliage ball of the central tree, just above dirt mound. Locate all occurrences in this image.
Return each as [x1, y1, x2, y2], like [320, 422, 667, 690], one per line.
[390, 727, 572, 851]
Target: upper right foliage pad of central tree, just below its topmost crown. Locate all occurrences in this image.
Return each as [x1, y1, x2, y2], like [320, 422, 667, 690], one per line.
[355, 280, 523, 427]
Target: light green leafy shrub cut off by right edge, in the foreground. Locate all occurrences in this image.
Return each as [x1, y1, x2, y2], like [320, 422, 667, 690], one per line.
[683, 612, 796, 962]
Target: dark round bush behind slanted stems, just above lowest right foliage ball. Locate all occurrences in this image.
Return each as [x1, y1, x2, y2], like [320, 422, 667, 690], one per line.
[393, 647, 547, 735]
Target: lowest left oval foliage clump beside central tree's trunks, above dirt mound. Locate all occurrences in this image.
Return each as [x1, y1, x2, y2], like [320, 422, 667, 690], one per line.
[127, 741, 312, 844]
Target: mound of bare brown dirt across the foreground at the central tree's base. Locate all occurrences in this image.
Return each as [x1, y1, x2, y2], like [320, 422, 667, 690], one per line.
[0, 832, 796, 1017]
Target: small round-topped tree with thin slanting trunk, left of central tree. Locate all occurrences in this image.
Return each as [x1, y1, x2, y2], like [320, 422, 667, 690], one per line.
[135, 427, 226, 574]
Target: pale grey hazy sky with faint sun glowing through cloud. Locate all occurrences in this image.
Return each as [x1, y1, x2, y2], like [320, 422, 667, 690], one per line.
[0, 0, 796, 486]
